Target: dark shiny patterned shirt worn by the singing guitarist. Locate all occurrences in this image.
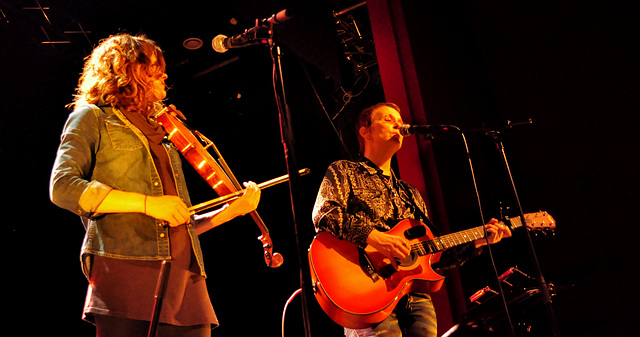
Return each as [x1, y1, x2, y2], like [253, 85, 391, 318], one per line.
[313, 158, 479, 268]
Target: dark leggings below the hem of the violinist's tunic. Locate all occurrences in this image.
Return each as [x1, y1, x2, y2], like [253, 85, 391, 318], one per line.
[95, 315, 211, 337]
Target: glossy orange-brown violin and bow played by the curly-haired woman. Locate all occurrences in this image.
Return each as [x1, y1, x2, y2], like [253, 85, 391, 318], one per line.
[154, 105, 288, 268]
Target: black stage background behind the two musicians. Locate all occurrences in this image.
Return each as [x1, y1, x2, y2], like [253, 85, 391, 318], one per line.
[0, 0, 640, 336]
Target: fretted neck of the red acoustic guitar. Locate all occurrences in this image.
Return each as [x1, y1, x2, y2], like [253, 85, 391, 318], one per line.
[412, 217, 522, 255]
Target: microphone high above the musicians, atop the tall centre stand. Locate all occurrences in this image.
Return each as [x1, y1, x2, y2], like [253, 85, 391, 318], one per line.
[211, 9, 292, 53]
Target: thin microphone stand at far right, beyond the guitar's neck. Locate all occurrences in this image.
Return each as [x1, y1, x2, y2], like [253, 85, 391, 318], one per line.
[485, 124, 560, 337]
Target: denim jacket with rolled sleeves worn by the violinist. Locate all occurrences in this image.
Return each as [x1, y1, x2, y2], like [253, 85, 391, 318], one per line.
[49, 105, 205, 278]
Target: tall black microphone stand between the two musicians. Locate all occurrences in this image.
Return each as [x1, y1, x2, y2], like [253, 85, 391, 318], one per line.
[268, 22, 311, 337]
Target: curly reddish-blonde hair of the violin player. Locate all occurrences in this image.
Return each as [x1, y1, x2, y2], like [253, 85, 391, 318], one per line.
[68, 33, 166, 113]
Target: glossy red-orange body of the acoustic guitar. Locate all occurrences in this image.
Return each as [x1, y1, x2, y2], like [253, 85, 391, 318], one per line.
[309, 219, 444, 328]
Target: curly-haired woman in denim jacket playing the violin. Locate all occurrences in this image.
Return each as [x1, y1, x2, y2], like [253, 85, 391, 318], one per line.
[49, 34, 260, 337]
